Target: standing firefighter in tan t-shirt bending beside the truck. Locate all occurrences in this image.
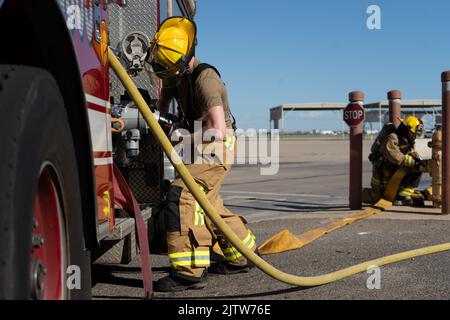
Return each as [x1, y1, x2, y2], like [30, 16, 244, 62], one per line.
[147, 17, 256, 292]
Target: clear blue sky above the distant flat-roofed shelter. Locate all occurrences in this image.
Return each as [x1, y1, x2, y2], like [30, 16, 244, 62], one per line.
[196, 0, 450, 130]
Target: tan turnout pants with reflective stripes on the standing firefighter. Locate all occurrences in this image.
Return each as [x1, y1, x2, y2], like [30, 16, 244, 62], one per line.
[165, 146, 256, 280]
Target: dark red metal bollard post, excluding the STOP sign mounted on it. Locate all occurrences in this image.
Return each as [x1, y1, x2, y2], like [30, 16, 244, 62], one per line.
[349, 91, 364, 210]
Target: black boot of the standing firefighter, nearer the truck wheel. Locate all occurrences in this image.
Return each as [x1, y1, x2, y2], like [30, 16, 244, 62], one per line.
[154, 270, 208, 292]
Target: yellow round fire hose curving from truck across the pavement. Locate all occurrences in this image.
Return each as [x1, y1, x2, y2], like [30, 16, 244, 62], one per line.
[108, 49, 450, 287]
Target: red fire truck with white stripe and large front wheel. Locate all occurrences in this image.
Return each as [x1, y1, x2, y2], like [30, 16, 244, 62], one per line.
[0, 0, 196, 299]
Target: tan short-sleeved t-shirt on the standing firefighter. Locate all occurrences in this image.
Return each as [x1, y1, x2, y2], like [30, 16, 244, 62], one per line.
[161, 60, 232, 129]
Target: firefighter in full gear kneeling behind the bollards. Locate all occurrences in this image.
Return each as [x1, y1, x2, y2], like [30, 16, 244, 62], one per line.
[363, 116, 426, 206]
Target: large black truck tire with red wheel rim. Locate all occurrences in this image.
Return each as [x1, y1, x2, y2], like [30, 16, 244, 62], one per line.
[0, 65, 91, 300]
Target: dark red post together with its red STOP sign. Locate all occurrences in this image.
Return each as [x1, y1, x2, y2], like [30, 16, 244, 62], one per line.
[344, 91, 365, 210]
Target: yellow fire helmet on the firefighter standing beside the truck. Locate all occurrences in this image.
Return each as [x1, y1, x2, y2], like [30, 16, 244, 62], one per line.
[147, 17, 197, 79]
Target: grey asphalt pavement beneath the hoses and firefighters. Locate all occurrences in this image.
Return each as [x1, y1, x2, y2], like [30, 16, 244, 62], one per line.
[93, 140, 450, 300]
